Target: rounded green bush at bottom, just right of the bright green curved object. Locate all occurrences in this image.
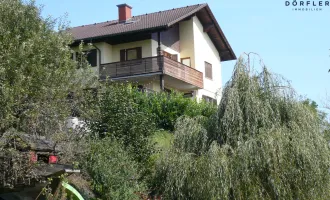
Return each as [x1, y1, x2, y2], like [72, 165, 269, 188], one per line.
[85, 137, 146, 199]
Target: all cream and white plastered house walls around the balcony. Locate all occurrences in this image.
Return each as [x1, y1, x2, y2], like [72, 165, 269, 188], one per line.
[70, 16, 222, 102]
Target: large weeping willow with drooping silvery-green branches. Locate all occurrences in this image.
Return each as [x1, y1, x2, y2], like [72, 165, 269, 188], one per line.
[156, 54, 330, 199]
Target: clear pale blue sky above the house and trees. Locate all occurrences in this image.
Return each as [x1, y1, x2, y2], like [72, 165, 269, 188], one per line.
[36, 0, 330, 107]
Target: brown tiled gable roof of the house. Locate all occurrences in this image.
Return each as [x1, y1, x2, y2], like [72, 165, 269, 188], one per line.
[69, 3, 236, 61]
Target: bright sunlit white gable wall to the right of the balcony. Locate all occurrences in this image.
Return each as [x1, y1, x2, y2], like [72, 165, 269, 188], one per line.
[191, 16, 222, 103]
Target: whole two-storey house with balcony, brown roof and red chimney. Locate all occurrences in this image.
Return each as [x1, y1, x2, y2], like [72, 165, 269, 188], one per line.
[70, 4, 236, 102]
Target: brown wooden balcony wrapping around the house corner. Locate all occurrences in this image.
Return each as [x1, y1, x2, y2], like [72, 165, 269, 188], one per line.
[99, 56, 203, 89]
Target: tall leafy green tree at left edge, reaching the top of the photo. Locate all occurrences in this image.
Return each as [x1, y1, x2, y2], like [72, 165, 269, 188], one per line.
[0, 0, 93, 186]
